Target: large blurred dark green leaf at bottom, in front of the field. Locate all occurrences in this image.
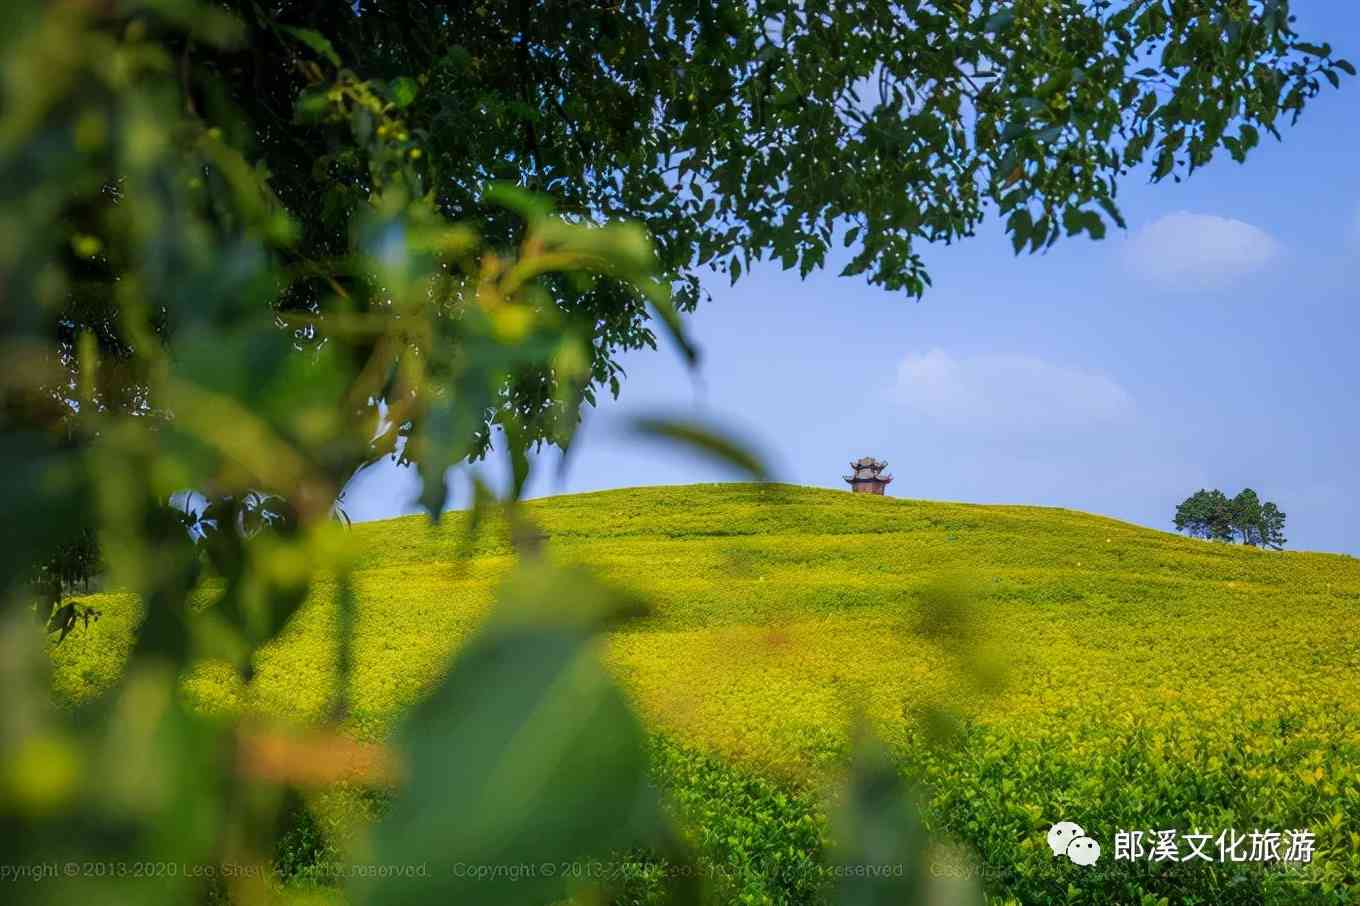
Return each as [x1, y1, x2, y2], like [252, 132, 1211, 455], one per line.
[356, 573, 654, 906]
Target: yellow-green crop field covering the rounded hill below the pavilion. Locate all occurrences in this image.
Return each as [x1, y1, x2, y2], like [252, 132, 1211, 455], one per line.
[53, 484, 1360, 903]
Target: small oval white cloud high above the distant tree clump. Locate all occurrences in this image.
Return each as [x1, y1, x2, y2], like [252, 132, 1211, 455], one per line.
[1125, 211, 1281, 288]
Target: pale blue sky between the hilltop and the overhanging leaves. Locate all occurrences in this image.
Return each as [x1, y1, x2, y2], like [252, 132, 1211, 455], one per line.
[347, 7, 1360, 554]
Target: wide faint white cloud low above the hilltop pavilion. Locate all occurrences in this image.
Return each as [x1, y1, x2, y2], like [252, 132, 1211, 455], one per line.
[896, 350, 1133, 430]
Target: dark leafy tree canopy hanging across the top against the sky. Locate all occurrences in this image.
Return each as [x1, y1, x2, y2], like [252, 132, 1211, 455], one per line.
[37, 0, 1353, 489]
